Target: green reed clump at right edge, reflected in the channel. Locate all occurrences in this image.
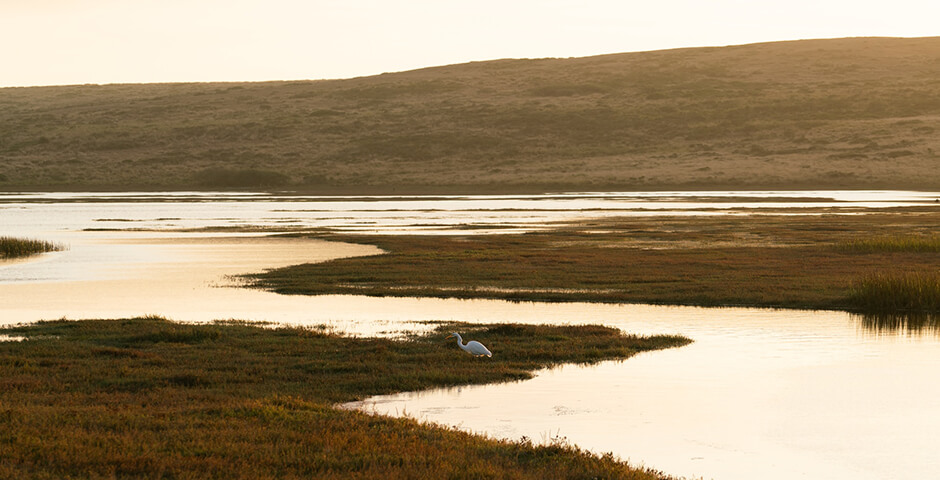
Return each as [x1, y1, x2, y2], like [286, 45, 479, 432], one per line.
[849, 271, 940, 312]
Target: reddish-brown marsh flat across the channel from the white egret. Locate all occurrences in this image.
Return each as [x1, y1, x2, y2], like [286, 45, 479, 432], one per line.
[253, 209, 940, 309]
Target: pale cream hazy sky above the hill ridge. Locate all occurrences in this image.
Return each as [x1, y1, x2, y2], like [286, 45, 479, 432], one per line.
[0, 0, 940, 87]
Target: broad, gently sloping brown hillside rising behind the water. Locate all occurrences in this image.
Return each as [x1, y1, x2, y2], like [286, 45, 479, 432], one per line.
[0, 37, 940, 193]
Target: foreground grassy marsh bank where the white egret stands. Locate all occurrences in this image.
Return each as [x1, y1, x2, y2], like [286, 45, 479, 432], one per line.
[0, 318, 687, 479]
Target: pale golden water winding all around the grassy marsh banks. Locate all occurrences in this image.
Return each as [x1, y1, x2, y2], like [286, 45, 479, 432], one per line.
[0, 192, 940, 479]
